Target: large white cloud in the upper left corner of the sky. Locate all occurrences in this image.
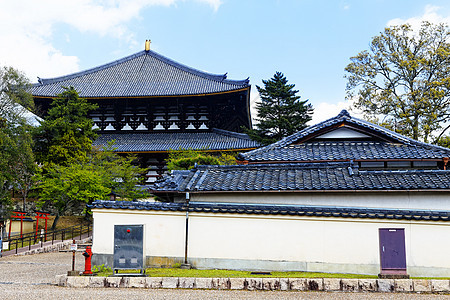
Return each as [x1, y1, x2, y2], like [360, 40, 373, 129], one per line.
[0, 0, 221, 82]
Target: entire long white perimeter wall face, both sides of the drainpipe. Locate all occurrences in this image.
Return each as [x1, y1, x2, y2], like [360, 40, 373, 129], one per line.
[93, 205, 450, 276]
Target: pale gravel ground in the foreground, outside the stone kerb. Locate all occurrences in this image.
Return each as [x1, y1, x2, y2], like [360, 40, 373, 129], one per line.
[0, 252, 450, 300]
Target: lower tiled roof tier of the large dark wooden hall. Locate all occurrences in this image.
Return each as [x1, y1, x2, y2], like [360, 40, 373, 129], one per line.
[93, 129, 259, 152]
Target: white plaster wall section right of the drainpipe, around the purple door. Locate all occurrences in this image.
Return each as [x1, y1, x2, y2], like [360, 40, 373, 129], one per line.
[189, 214, 450, 274]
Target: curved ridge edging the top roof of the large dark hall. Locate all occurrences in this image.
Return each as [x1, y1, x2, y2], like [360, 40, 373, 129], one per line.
[33, 50, 249, 86]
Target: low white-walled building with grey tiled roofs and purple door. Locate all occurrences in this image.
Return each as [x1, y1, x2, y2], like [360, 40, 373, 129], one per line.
[91, 111, 450, 278]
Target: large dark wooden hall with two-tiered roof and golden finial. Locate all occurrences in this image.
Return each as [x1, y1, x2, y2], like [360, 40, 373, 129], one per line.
[32, 41, 258, 182]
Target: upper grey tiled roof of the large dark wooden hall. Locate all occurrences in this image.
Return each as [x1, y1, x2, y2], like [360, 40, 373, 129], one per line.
[31, 51, 249, 98]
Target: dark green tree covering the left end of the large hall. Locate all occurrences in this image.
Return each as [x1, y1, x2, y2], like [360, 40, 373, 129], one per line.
[35, 87, 98, 166]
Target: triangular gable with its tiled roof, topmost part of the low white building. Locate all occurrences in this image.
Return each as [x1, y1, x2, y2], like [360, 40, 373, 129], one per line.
[239, 110, 450, 169]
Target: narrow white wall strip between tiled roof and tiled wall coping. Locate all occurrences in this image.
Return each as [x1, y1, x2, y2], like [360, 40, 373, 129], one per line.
[191, 191, 450, 211]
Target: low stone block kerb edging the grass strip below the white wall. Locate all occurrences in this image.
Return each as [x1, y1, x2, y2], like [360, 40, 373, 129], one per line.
[54, 275, 450, 293]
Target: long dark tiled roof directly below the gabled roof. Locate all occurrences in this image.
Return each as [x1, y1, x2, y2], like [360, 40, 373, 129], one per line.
[154, 163, 450, 192]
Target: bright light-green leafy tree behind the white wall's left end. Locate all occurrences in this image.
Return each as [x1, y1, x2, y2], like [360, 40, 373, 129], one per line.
[37, 141, 149, 228]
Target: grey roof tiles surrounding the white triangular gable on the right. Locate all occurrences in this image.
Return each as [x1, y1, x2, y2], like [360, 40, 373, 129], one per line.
[239, 110, 450, 161]
